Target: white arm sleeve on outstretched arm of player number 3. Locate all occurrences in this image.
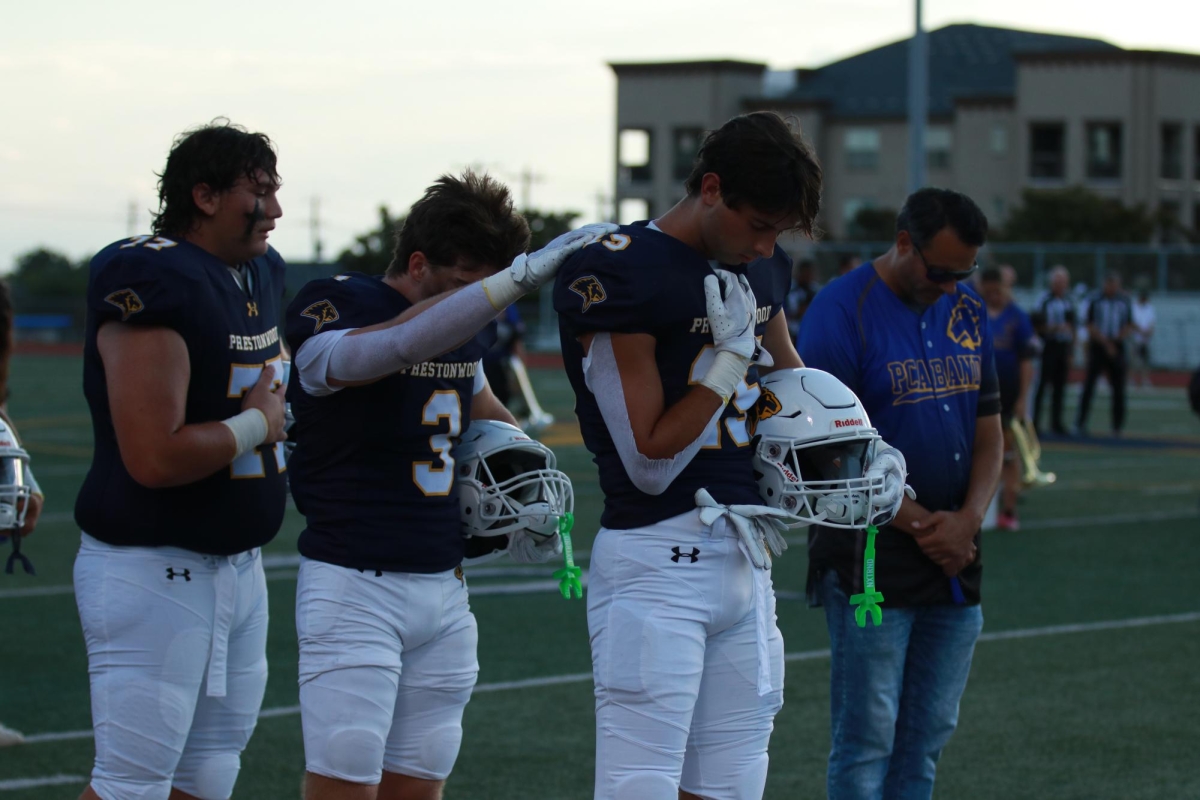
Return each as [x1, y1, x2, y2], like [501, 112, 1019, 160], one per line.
[294, 283, 498, 397]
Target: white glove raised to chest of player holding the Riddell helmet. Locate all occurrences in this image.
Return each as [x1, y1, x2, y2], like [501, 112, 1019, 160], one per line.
[700, 269, 774, 402]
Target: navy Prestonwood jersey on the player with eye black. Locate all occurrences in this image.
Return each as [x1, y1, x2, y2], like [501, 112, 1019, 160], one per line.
[76, 236, 286, 555]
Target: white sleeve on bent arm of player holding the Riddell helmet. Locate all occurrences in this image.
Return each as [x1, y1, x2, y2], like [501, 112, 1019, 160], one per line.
[583, 333, 725, 494]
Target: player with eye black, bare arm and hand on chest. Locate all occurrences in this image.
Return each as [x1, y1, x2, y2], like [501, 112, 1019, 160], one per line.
[74, 120, 284, 800]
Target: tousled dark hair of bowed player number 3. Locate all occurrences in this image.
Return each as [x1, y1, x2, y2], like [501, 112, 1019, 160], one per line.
[388, 169, 529, 276]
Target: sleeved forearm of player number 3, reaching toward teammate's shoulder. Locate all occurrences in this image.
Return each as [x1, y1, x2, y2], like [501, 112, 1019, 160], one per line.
[324, 283, 497, 385]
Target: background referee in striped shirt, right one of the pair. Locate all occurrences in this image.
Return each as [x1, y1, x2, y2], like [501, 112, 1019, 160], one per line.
[1075, 272, 1133, 437]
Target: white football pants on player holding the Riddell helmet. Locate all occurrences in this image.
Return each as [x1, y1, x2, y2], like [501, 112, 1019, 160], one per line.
[588, 511, 784, 800]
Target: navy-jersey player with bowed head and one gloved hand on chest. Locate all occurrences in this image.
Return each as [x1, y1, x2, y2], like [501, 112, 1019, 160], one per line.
[554, 112, 821, 800]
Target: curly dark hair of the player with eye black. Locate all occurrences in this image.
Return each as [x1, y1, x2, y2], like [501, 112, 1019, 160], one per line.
[151, 118, 282, 236]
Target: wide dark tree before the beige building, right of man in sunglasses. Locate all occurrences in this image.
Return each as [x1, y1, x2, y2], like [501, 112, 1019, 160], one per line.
[994, 186, 1157, 243]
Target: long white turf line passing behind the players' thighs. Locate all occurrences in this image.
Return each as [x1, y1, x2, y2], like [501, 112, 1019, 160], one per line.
[11, 612, 1200, 762]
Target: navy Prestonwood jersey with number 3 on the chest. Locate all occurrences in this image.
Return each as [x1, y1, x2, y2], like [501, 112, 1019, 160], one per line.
[284, 272, 494, 573]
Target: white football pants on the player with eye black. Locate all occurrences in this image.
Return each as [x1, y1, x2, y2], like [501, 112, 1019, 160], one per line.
[74, 534, 268, 800]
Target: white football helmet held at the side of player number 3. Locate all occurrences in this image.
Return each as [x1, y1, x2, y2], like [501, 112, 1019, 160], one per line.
[452, 420, 575, 564]
